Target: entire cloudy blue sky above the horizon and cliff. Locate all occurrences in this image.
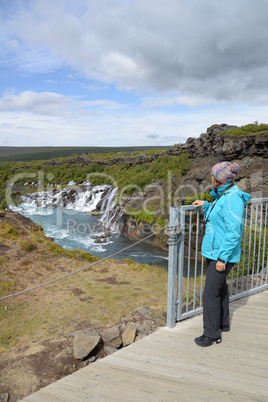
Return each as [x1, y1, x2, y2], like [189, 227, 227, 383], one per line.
[0, 0, 268, 147]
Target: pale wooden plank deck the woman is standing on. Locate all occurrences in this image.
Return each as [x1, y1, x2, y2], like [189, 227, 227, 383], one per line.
[23, 291, 268, 402]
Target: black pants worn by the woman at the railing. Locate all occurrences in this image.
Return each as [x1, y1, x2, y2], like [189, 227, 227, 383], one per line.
[203, 259, 234, 338]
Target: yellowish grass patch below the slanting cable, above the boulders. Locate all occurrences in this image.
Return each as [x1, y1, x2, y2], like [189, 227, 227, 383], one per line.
[0, 261, 167, 351]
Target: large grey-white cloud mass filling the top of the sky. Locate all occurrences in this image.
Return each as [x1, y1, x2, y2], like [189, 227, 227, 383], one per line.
[2, 0, 268, 103]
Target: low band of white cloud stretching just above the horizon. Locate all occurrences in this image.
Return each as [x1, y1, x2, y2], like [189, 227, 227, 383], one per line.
[0, 102, 268, 147]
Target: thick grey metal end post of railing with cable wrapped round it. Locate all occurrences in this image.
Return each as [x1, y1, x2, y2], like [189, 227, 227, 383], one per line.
[167, 207, 179, 328]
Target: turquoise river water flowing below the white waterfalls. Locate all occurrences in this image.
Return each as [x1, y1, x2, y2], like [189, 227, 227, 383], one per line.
[16, 204, 168, 269]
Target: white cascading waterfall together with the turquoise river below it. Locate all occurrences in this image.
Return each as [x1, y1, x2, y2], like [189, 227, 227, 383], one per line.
[12, 183, 167, 267]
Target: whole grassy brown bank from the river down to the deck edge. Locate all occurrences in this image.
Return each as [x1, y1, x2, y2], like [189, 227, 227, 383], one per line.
[0, 211, 167, 402]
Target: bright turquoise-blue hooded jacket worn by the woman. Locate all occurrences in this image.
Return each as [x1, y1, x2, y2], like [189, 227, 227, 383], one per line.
[201, 183, 251, 264]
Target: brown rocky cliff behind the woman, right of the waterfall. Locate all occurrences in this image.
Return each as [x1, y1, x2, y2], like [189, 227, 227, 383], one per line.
[113, 124, 268, 247]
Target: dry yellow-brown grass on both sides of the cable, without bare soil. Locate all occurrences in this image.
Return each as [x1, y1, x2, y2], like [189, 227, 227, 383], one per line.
[0, 211, 170, 352]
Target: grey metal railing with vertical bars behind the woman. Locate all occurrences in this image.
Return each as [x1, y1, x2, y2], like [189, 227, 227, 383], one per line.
[167, 198, 268, 328]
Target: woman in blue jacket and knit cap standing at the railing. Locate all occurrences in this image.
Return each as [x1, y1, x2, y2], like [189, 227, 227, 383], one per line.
[193, 162, 251, 346]
